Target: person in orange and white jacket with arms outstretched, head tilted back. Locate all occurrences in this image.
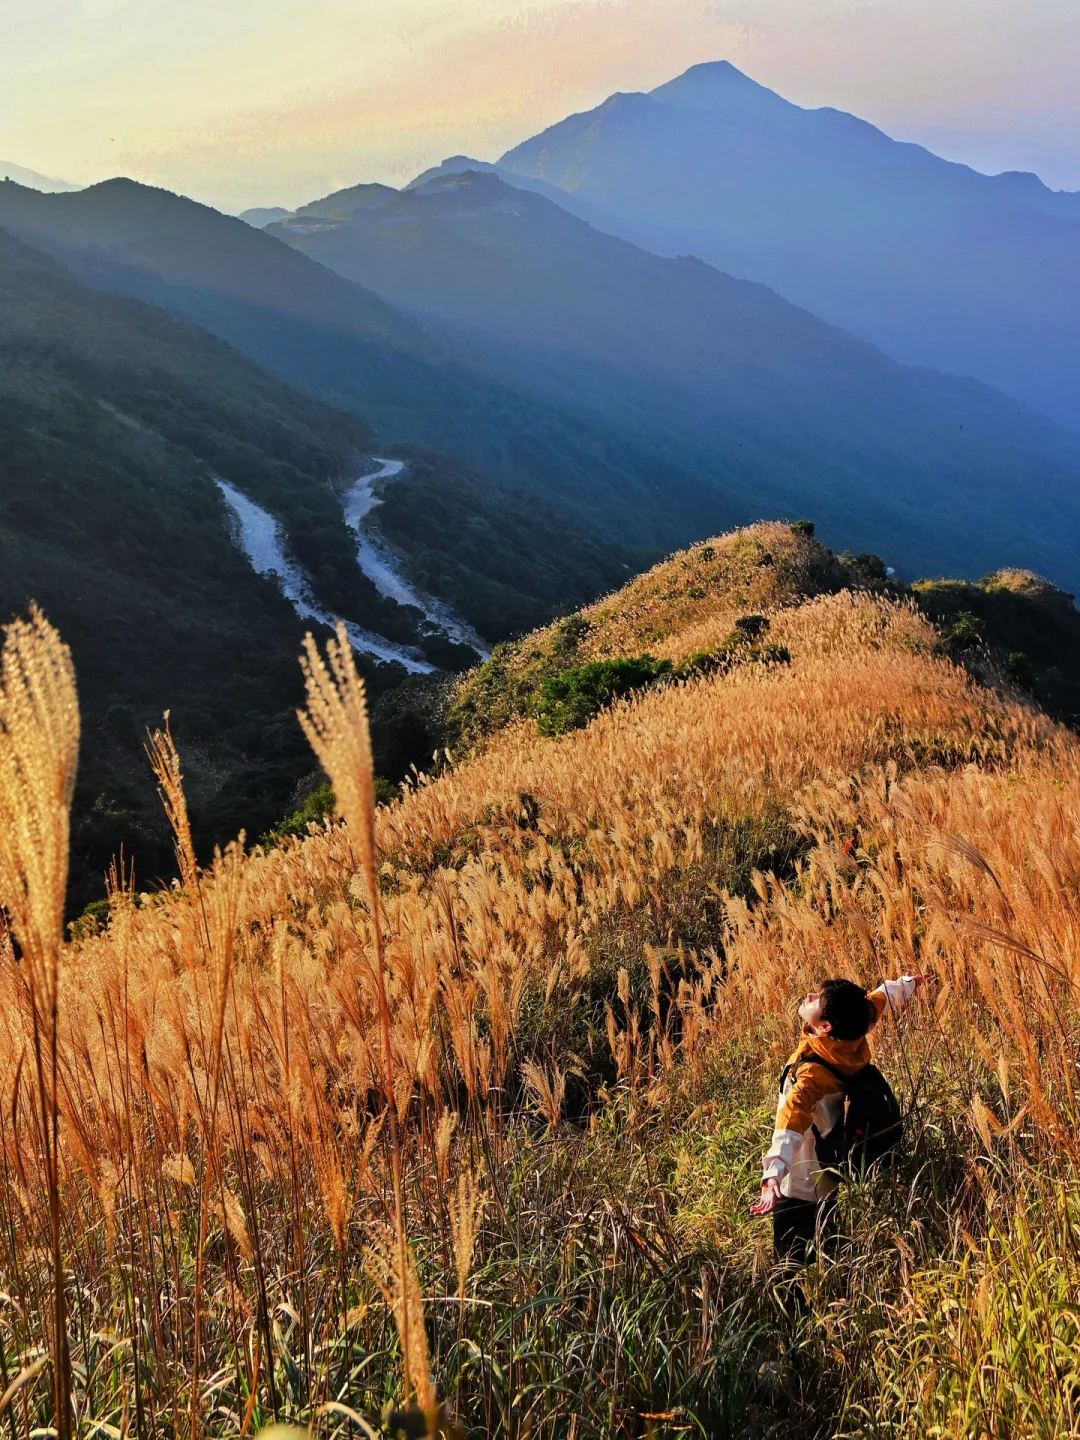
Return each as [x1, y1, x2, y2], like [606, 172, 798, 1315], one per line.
[750, 973, 935, 1269]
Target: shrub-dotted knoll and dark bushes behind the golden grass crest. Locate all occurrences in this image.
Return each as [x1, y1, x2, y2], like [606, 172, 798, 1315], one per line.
[445, 521, 1080, 755]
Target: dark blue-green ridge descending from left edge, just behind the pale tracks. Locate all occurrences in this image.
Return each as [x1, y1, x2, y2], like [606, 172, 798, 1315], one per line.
[0, 172, 722, 553]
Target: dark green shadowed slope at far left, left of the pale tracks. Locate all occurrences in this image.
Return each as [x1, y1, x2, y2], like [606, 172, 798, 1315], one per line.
[0, 223, 377, 899]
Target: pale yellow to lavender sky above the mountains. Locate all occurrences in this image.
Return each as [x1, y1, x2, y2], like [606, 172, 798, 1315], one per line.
[0, 0, 1080, 212]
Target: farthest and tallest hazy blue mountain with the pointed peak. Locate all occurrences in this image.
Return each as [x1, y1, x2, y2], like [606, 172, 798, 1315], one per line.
[500, 62, 1080, 429]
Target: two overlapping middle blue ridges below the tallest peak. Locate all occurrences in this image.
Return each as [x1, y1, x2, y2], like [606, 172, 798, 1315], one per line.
[8, 174, 1080, 590]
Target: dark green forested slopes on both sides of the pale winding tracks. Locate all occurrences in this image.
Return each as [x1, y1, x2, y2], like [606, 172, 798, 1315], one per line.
[0, 230, 625, 901]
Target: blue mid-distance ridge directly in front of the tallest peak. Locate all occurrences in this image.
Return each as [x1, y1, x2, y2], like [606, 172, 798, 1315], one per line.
[266, 171, 1080, 585]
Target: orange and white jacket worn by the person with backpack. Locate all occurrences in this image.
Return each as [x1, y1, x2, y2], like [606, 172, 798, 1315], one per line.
[762, 975, 916, 1200]
